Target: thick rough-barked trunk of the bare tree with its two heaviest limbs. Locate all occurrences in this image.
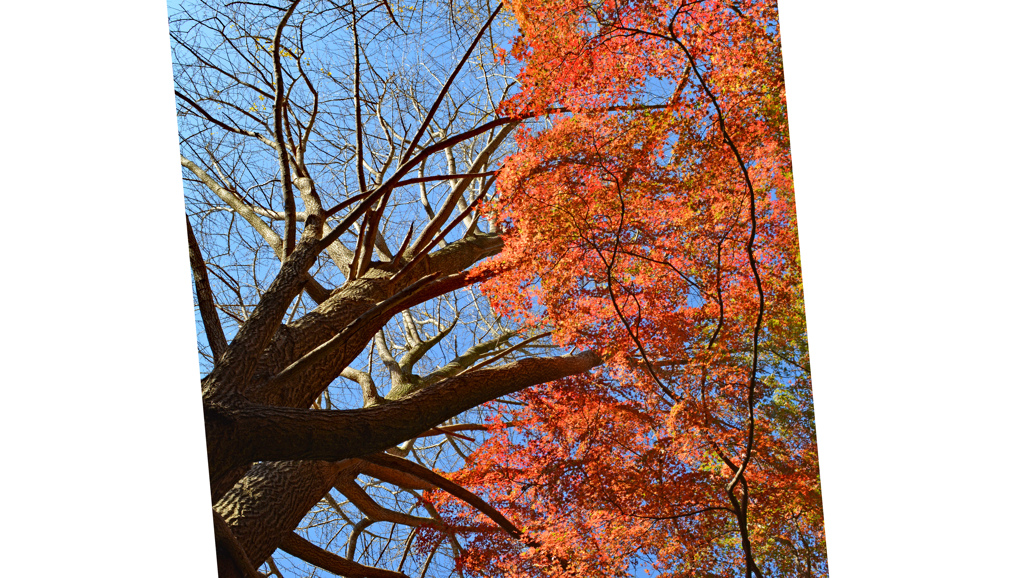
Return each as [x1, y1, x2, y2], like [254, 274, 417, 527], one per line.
[198, 229, 600, 576]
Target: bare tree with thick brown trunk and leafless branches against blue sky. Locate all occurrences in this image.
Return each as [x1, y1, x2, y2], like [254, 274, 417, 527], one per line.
[171, 0, 600, 576]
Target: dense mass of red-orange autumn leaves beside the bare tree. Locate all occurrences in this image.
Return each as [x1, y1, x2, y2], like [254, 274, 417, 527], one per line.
[434, 0, 826, 576]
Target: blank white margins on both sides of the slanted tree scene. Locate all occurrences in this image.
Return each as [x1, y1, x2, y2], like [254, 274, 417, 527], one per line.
[0, 0, 1024, 578]
